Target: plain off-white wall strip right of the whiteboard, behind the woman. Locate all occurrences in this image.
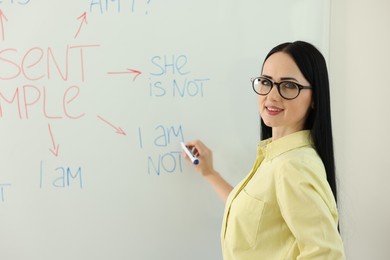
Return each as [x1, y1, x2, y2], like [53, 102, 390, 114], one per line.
[329, 0, 390, 260]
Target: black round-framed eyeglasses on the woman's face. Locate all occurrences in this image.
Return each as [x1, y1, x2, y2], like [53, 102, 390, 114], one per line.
[251, 77, 312, 100]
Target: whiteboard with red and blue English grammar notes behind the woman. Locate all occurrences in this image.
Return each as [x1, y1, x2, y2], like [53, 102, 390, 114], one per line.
[0, 0, 329, 260]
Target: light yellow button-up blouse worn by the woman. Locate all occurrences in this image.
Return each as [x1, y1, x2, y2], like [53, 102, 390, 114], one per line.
[221, 130, 345, 260]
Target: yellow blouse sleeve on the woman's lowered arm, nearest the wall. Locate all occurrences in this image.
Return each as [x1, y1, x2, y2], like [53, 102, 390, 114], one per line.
[276, 157, 345, 260]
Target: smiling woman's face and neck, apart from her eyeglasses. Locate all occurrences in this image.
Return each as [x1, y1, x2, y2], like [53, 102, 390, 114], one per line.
[258, 52, 313, 139]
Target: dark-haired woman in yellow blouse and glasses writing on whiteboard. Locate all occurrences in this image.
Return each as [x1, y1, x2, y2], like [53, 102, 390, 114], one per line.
[184, 41, 345, 260]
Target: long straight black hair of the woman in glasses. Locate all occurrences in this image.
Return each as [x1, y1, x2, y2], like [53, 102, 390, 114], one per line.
[260, 41, 337, 202]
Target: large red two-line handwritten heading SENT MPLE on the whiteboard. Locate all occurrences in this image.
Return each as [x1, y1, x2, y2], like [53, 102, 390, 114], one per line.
[0, 44, 100, 119]
